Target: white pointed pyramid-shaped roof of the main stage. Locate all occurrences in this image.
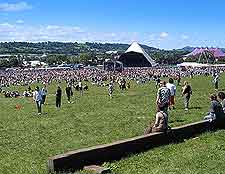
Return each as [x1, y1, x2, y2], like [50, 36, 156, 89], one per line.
[125, 42, 157, 66]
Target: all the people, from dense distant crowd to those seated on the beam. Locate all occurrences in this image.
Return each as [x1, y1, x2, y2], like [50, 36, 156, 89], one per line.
[0, 67, 225, 133]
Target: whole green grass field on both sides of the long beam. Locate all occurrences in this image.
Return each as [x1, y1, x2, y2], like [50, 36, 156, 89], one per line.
[0, 76, 225, 174]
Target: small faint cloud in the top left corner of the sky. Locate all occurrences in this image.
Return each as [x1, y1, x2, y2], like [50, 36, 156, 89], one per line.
[0, 2, 32, 12]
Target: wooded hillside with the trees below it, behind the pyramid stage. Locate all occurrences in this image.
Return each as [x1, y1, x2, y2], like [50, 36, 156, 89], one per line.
[0, 42, 192, 67]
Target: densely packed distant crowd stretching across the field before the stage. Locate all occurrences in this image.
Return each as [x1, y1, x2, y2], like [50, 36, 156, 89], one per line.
[0, 67, 225, 86]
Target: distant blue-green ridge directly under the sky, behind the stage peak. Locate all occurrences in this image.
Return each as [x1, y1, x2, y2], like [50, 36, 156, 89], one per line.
[0, 42, 159, 55]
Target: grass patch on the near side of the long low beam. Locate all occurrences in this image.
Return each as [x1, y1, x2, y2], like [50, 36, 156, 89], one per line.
[104, 130, 225, 174]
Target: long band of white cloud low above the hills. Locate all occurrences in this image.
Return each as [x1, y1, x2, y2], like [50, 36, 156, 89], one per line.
[0, 23, 176, 48]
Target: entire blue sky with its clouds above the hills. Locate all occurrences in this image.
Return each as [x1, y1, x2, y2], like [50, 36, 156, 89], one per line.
[0, 0, 225, 49]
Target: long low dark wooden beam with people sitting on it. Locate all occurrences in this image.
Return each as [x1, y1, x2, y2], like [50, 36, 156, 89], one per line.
[48, 120, 225, 173]
